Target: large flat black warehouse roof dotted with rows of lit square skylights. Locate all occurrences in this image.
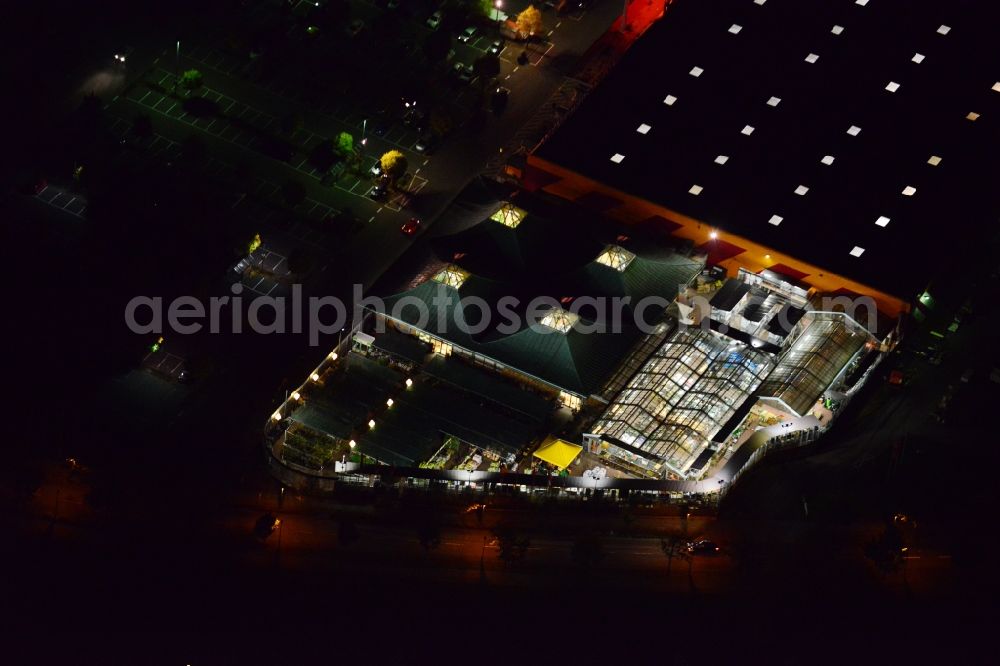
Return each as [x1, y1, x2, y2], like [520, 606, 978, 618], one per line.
[537, 0, 1000, 298]
